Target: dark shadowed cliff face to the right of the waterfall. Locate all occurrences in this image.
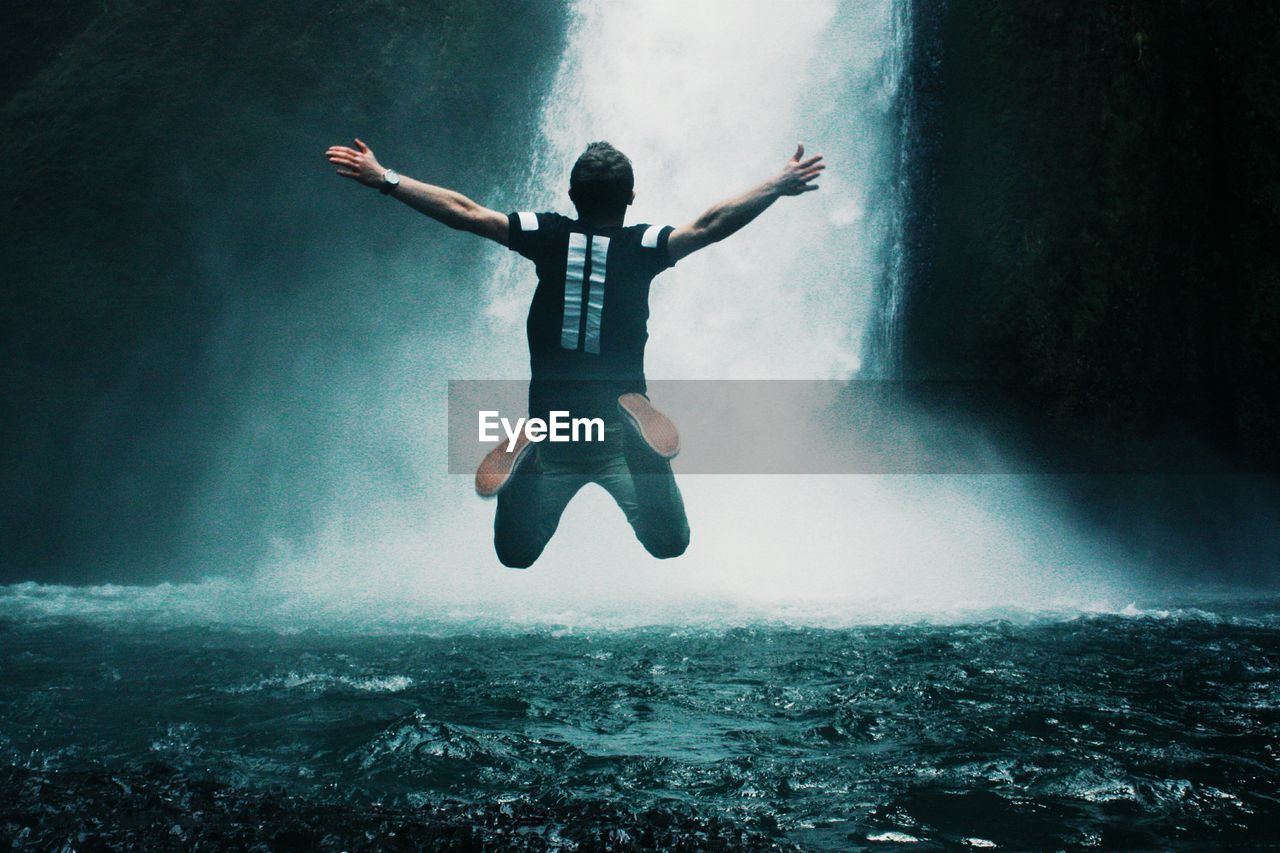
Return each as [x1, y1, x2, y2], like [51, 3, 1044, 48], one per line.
[902, 0, 1280, 470]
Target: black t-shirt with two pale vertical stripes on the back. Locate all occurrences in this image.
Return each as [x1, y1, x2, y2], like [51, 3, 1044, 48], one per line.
[508, 213, 673, 419]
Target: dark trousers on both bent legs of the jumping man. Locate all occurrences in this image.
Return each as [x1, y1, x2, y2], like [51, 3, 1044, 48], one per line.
[493, 421, 689, 569]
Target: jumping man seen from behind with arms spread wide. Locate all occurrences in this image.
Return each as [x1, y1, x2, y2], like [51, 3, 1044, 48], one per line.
[325, 138, 826, 569]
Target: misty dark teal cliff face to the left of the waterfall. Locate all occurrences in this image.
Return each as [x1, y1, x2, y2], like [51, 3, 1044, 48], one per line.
[0, 0, 566, 580]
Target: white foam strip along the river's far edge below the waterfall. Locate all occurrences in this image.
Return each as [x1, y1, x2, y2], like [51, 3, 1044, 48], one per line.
[0, 564, 1177, 630]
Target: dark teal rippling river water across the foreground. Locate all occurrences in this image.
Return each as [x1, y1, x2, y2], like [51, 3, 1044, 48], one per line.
[0, 585, 1280, 849]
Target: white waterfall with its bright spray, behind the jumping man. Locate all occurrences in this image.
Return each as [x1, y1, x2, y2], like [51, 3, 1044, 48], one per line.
[232, 0, 1131, 622]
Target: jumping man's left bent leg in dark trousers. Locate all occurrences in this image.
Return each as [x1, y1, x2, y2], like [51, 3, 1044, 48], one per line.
[493, 456, 586, 569]
